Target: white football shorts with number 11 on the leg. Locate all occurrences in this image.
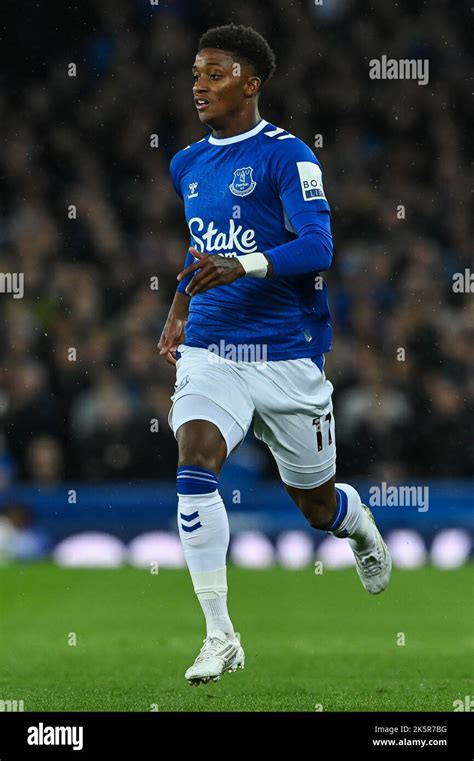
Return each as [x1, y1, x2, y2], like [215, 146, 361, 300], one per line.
[168, 344, 336, 489]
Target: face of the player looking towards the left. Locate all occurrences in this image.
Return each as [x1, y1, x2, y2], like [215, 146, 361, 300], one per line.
[193, 48, 260, 124]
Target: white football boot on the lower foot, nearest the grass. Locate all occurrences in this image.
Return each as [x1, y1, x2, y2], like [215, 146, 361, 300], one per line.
[184, 631, 245, 685]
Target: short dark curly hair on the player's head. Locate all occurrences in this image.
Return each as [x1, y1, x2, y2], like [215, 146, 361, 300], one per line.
[198, 24, 276, 86]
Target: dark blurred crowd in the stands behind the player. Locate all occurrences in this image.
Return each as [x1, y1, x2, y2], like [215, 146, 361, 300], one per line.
[0, 0, 474, 485]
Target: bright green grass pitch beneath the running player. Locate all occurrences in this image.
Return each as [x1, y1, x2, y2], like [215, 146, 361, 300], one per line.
[0, 564, 474, 711]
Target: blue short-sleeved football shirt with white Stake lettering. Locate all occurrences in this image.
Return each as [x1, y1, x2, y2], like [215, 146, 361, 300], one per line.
[170, 119, 331, 361]
